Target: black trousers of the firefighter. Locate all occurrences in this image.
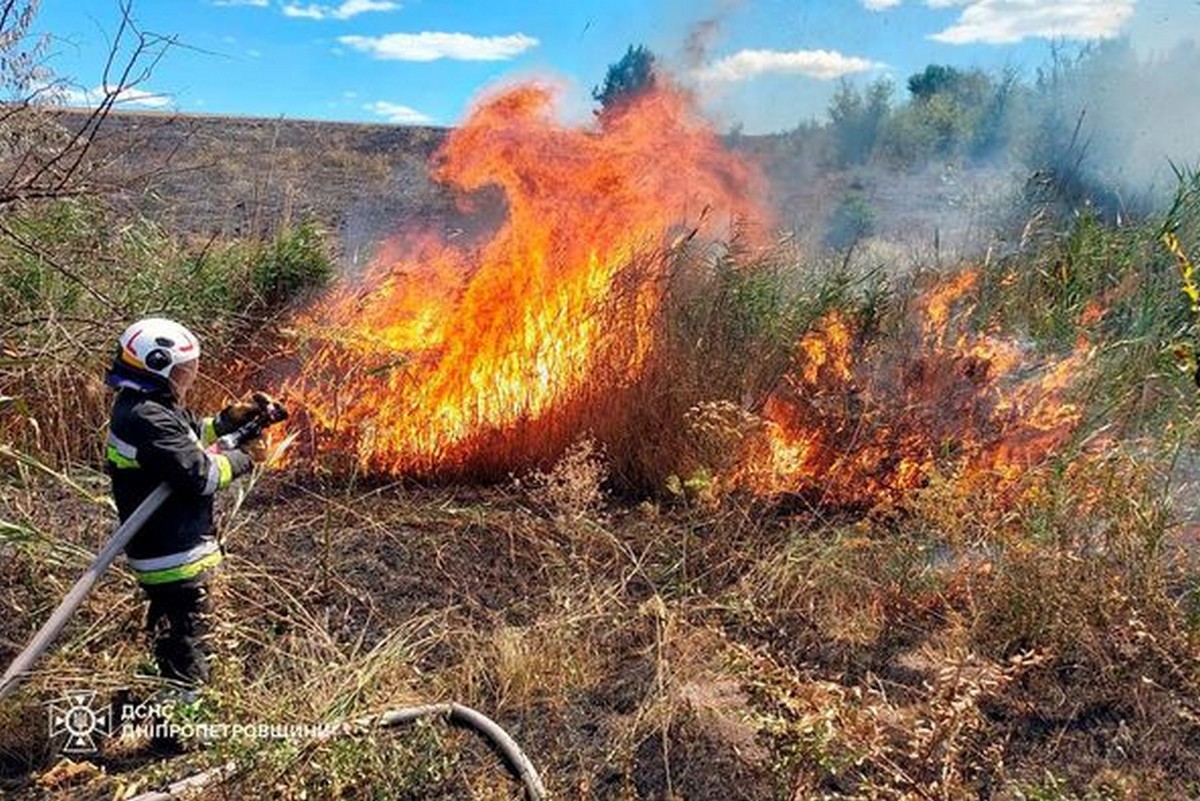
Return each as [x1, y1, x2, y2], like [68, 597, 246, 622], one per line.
[142, 579, 209, 686]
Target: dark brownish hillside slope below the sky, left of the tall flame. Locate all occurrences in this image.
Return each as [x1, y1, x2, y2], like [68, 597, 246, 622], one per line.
[60, 112, 454, 248]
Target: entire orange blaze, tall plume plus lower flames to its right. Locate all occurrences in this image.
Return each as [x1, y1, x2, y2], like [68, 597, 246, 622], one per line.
[288, 81, 1093, 505]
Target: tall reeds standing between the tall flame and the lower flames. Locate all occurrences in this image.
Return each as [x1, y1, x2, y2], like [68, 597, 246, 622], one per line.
[588, 239, 888, 495]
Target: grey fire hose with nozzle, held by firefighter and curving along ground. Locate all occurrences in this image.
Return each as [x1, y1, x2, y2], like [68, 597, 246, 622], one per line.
[0, 404, 546, 801]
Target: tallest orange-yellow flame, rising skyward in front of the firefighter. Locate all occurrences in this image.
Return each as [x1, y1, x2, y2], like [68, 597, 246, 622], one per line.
[289, 86, 762, 472]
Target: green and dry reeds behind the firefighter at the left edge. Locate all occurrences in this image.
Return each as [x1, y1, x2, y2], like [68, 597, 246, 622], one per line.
[0, 200, 332, 465]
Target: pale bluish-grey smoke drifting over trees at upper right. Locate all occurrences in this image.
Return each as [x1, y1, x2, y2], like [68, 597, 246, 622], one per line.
[700, 38, 1200, 256]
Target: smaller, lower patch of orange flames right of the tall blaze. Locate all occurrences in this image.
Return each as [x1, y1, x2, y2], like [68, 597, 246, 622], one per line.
[748, 271, 1088, 505]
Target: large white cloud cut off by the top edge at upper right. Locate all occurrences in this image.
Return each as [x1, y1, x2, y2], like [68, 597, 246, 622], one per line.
[930, 0, 1136, 44]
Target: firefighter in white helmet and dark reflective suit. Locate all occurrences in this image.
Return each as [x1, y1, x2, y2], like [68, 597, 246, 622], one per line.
[106, 318, 265, 698]
